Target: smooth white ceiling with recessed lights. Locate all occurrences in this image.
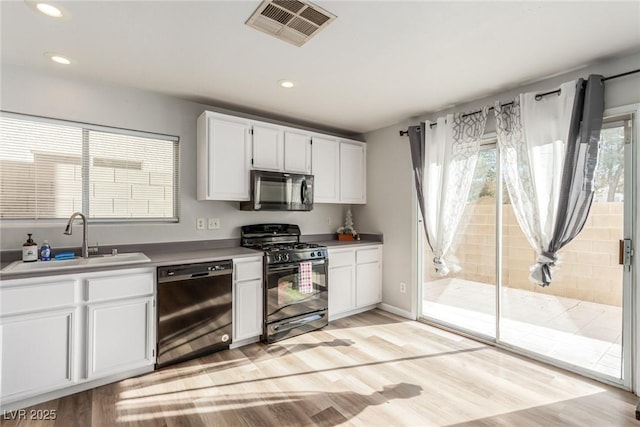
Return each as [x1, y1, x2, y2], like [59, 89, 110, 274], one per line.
[0, 0, 640, 133]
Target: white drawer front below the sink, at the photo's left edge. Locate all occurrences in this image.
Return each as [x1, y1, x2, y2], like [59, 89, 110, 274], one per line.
[0, 280, 76, 316]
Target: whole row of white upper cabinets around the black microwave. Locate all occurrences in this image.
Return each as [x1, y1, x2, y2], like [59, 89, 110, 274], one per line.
[197, 111, 366, 204]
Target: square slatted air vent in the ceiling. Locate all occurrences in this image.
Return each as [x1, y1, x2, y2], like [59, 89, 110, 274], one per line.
[246, 0, 336, 46]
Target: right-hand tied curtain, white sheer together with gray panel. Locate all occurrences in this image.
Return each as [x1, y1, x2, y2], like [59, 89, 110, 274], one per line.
[495, 76, 604, 286]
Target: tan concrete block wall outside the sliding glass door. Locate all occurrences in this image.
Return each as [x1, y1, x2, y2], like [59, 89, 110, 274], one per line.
[424, 197, 623, 306]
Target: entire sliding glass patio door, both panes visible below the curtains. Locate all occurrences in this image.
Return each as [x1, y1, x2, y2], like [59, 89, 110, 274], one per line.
[418, 114, 635, 386]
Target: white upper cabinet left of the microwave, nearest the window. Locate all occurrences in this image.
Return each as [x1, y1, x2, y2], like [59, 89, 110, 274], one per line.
[198, 111, 251, 201]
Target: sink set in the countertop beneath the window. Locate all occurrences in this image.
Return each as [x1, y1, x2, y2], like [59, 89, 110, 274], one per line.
[0, 252, 151, 273]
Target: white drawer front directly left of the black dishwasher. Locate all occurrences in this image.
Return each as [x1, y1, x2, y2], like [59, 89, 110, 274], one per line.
[87, 273, 153, 301]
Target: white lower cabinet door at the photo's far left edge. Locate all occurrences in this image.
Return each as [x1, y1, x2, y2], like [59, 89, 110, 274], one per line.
[0, 309, 75, 402]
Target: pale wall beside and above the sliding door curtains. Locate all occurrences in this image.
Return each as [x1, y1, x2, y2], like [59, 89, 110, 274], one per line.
[354, 54, 640, 318]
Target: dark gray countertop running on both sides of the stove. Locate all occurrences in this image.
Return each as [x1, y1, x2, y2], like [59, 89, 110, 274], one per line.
[0, 236, 382, 281]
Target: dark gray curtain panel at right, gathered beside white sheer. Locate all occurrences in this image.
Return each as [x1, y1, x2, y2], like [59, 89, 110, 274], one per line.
[540, 75, 604, 286]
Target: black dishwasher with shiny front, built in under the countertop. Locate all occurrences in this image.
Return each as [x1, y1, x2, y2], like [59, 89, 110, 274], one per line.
[156, 261, 233, 369]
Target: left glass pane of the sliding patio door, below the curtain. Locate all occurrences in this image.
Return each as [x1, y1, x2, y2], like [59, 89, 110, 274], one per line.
[420, 144, 499, 339]
